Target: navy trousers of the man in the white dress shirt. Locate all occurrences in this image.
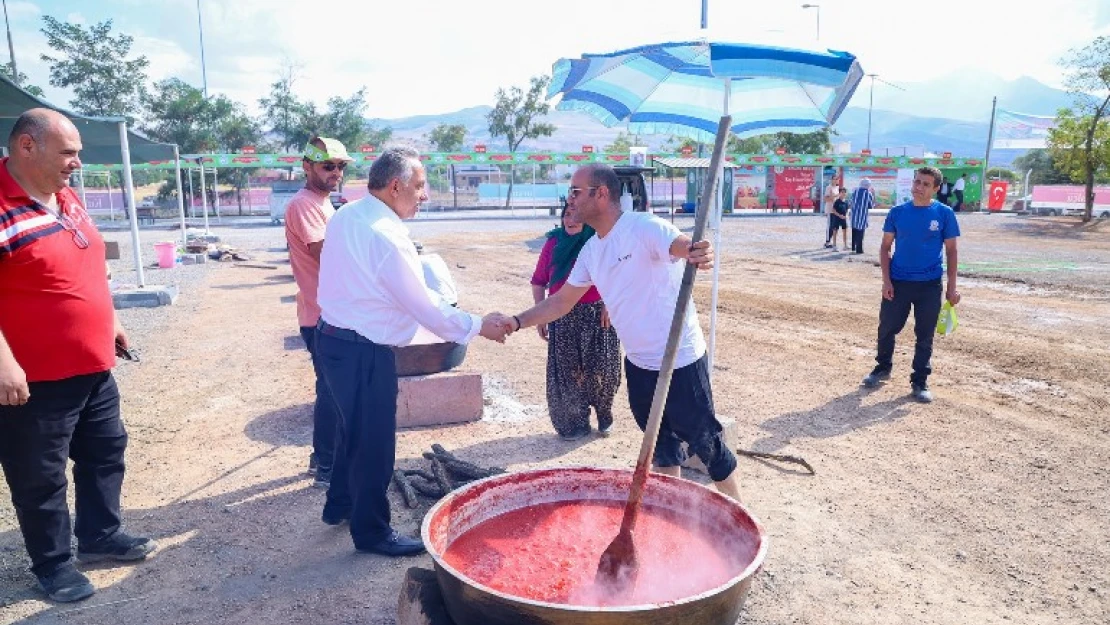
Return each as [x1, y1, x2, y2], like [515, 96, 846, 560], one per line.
[316, 322, 397, 548]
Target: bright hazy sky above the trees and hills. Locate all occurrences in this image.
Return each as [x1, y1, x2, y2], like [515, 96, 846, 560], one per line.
[0, 0, 1110, 118]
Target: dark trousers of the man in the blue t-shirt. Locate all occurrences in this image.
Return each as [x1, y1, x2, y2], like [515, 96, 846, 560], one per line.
[872, 280, 942, 384]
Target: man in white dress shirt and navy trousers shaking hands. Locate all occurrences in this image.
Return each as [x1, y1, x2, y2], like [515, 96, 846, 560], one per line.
[316, 148, 507, 556]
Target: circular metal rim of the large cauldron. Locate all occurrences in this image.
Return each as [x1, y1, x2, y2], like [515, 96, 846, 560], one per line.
[421, 465, 769, 614]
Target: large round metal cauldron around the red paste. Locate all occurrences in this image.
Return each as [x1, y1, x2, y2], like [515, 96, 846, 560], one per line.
[421, 467, 767, 625]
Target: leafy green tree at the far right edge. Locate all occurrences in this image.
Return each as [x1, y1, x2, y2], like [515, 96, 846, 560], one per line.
[1048, 37, 1110, 222]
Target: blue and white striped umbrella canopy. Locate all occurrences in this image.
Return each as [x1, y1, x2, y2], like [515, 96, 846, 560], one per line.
[547, 41, 864, 143]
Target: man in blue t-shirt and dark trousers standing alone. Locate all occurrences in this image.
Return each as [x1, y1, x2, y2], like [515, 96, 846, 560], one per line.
[864, 167, 960, 403]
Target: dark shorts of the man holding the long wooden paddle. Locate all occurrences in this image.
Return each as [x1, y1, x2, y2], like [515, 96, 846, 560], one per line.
[625, 356, 736, 482]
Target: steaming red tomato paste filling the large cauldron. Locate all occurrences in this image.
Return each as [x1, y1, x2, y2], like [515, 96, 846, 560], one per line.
[443, 500, 756, 606]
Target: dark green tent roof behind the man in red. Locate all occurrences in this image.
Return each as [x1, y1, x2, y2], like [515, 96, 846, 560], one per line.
[0, 74, 173, 164]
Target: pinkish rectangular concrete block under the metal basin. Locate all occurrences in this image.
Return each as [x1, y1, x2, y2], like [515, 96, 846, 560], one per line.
[397, 372, 484, 427]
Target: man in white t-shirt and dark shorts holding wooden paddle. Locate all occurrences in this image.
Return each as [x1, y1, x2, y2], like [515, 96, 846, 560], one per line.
[511, 165, 740, 501]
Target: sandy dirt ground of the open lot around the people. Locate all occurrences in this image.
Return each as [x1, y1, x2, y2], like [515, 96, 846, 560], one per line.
[0, 215, 1110, 625]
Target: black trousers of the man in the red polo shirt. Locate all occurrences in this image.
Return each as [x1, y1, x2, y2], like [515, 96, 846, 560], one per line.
[0, 371, 128, 576]
